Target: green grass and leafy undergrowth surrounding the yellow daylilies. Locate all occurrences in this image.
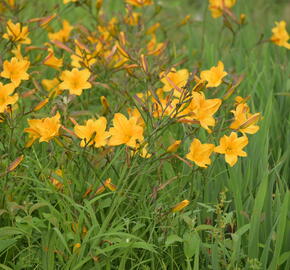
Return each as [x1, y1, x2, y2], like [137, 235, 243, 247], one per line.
[0, 0, 290, 270]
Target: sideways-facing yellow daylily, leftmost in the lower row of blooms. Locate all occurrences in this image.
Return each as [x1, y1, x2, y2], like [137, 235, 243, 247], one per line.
[24, 112, 61, 147]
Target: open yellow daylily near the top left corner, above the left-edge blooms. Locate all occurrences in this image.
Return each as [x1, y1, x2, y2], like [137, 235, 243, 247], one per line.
[3, 20, 31, 44]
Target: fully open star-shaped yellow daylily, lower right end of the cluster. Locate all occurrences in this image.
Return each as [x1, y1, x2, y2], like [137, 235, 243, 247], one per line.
[214, 132, 248, 167]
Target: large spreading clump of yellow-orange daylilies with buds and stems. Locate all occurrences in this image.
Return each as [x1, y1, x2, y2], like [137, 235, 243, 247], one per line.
[0, 0, 264, 221]
